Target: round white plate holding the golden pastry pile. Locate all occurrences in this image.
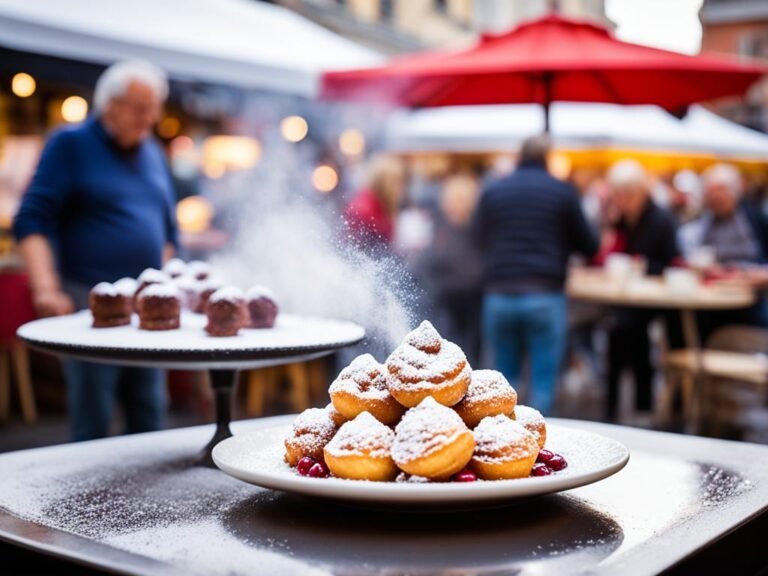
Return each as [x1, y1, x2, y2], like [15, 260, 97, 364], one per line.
[213, 425, 629, 506]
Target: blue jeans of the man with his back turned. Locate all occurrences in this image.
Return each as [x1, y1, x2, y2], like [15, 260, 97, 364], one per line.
[483, 292, 567, 414]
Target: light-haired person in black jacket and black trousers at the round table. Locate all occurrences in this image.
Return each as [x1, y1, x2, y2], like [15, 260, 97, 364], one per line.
[596, 160, 679, 420]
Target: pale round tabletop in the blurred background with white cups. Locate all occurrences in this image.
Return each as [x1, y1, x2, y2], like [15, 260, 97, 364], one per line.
[566, 268, 755, 310]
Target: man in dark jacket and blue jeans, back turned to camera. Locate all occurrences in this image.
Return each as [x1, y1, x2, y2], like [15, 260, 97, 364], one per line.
[474, 136, 598, 414]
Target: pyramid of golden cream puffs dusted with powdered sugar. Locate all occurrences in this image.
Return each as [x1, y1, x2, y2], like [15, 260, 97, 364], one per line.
[285, 321, 564, 482]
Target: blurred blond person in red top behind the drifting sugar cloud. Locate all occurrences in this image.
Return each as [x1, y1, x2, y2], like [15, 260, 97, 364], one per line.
[344, 155, 406, 253]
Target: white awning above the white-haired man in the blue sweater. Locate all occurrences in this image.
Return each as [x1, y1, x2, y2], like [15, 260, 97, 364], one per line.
[0, 0, 380, 97]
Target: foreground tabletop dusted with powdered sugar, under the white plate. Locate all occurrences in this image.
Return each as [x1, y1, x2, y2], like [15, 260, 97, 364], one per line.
[0, 417, 768, 575]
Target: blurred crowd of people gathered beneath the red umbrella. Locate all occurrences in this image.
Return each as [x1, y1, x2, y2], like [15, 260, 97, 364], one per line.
[346, 136, 768, 420]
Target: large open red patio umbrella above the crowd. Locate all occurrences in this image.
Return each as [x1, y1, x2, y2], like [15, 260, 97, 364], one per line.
[321, 13, 768, 129]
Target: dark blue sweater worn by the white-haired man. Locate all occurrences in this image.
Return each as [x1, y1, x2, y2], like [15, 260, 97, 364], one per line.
[13, 118, 176, 286]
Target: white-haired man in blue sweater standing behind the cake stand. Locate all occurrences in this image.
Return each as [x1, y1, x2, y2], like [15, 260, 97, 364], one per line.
[14, 61, 176, 440]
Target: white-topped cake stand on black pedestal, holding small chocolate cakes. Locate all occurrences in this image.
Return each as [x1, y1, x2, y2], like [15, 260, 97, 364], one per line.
[17, 311, 365, 467]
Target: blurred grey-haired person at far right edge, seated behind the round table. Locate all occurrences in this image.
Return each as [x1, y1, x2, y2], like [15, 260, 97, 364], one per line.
[679, 164, 768, 338]
